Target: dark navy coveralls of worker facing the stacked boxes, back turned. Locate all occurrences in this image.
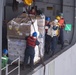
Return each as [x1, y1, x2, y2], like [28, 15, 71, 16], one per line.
[24, 39, 39, 66]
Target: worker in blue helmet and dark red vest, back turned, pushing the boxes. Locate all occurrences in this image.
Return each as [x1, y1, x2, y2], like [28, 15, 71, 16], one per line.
[24, 32, 39, 68]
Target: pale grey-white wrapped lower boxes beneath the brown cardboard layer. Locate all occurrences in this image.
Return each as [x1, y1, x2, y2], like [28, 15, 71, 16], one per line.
[8, 38, 40, 62]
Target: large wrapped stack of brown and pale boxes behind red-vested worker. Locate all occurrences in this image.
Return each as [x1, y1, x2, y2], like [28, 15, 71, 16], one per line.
[7, 14, 45, 62]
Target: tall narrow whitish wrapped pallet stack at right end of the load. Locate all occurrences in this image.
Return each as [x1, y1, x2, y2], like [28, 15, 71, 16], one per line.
[36, 15, 45, 57]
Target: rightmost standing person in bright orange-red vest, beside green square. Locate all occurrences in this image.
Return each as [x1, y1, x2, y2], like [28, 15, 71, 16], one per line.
[58, 14, 65, 49]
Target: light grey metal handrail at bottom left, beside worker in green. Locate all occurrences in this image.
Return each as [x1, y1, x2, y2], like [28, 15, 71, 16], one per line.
[1, 57, 20, 75]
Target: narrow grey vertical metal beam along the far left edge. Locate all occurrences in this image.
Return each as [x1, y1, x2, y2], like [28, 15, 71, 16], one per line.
[0, 0, 4, 75]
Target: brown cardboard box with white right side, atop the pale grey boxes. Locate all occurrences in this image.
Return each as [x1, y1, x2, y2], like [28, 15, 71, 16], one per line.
[7, 20, 39, 39]
